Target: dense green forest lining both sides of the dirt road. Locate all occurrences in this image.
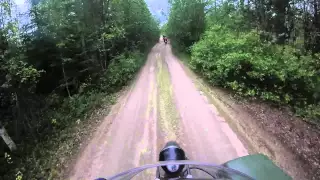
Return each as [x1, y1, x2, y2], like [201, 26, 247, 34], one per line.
[0, 0, 320, 180]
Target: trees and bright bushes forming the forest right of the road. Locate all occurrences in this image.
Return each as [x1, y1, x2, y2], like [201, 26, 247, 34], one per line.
[163, 0, 320, 124]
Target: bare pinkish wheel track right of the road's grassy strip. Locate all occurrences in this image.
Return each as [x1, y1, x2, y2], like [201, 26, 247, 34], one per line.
[162, 45, 248, 164]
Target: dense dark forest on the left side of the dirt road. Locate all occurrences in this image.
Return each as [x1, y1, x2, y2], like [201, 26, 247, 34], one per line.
[0, 0, 159, 179]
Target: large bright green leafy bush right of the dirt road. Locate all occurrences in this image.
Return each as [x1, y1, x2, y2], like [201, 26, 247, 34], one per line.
[190, 25, 320, 120]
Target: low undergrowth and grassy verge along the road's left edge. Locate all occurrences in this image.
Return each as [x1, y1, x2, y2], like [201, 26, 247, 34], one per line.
[0, 52, 145, 180]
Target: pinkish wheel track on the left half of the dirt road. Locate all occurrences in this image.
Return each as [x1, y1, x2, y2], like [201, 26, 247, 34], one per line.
[68, 46, 158, 180]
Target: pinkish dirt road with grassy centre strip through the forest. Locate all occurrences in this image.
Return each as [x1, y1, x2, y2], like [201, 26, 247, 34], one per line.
[68, 43, 247, 179]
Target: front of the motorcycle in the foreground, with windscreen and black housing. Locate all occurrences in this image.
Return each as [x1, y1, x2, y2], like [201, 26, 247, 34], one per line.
[96, 142, 292, 180]
